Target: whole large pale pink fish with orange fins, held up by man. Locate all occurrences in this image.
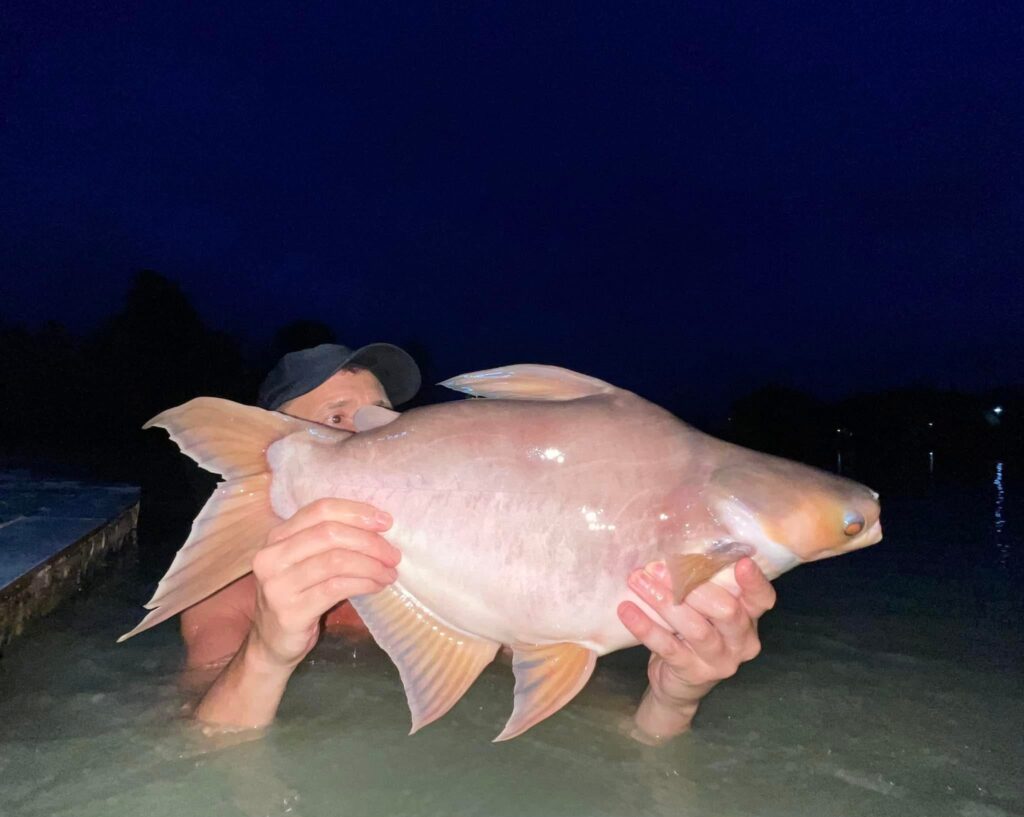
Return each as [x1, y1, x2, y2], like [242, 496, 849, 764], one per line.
[123, 364, 882, 740]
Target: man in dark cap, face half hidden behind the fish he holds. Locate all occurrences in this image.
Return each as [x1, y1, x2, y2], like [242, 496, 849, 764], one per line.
[172, 343, 775, 742]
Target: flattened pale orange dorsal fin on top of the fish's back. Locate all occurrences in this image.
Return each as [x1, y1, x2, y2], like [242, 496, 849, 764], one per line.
[440, 363, 616, 400]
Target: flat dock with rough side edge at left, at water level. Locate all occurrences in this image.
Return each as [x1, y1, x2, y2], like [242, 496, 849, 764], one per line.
[0, 472, 139, 647]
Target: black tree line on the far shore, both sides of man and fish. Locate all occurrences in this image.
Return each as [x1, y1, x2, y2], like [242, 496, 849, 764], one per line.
[0, 271, 1024, 492]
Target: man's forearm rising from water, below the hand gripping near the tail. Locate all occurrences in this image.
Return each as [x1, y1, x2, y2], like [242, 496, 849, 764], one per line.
[195, 633, 294, 729]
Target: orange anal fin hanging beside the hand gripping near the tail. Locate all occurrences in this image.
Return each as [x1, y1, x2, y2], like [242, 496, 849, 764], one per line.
[351, 585, 501, 734]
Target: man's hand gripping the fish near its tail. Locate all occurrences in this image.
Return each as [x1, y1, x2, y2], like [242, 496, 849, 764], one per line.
[247, 499, 401, 668]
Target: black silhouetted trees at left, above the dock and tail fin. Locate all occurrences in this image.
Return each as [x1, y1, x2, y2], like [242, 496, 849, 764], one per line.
[0, 272, 247, 481]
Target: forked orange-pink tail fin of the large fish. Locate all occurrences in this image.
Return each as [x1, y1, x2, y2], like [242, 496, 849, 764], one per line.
[118, 397, 327, 641]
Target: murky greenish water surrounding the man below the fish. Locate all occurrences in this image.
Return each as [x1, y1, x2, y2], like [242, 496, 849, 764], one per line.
[0, 466, 1024, 817]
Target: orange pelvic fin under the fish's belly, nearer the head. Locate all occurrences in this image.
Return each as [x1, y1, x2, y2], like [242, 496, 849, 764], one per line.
[495, 643, 597, 742]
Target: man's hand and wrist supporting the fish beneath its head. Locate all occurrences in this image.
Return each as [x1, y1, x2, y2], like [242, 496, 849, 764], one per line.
[618, 558, 775, 742]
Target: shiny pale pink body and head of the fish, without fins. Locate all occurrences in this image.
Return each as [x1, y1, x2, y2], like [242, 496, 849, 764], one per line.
[268, 382, 877, 654]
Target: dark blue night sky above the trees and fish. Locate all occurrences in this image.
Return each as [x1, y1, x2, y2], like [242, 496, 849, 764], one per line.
[0, 0, 1024, 415]
